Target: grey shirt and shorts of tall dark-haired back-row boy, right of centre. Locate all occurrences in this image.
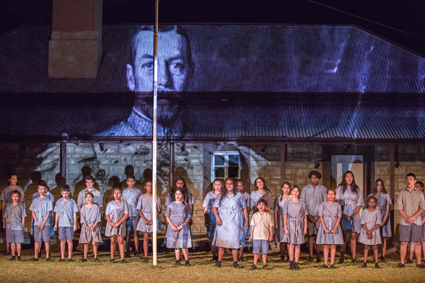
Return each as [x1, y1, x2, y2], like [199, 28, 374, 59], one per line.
[300, 184, 327, 236]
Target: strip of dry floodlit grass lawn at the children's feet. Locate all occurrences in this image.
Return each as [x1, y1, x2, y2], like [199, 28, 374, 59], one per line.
[0, 250, 425, 283]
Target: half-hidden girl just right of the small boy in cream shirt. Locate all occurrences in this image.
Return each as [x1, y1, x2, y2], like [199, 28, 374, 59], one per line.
[273, 182, 292, 262]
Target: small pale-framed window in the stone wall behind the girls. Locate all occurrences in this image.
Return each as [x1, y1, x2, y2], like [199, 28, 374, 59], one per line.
[211, 151, 242, 181]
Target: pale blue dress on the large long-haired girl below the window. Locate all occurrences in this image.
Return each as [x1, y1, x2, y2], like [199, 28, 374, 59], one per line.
[212, 192, 246, 249]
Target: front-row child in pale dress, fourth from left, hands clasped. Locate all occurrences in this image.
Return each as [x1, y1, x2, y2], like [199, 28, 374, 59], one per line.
[80, 192, 102, 262]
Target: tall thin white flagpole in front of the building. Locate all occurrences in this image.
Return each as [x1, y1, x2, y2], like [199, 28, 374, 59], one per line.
[152, 0, 159, 266]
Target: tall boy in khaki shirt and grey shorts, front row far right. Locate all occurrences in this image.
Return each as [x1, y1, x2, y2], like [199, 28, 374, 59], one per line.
[397, 173, 425, 268]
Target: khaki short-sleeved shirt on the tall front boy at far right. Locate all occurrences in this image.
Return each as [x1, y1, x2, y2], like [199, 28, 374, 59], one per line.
[397, 188, 425, 226]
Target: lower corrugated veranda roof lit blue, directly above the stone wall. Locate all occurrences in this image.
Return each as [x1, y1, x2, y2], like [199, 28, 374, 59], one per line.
[0, 105, 425, 141]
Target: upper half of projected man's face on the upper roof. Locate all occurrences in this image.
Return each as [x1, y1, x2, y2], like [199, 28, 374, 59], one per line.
[127, 30, 190, 92]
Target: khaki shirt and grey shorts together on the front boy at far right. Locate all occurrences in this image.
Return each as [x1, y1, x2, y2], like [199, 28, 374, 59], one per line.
[397, 188, 425, 242]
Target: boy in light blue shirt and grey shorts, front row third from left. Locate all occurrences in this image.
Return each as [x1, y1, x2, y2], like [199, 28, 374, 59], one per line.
[53, 185, 78, 262]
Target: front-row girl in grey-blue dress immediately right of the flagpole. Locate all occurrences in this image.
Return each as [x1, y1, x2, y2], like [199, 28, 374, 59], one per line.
[165, 188, 192, 266]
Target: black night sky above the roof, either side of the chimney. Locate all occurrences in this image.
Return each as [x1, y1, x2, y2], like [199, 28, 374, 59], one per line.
[0, 0, 425, 56]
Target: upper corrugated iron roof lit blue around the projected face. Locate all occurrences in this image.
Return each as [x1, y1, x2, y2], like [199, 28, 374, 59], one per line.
[0, 25, 425, 93]
